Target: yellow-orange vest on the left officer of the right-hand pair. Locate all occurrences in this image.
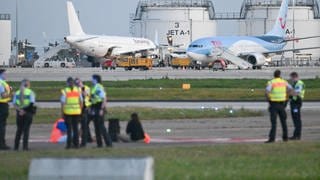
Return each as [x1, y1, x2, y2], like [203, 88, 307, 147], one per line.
[268, 78, 288, 102]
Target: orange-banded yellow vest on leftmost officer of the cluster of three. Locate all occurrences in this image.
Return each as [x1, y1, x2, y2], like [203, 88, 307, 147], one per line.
[62, 87, 81, 115]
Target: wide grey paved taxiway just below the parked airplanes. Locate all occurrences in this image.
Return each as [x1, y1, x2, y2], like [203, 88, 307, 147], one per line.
[7, 67, 320, 81]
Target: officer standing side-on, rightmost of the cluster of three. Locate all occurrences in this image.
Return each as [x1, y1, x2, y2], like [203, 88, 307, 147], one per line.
[91, 74, 112, 147]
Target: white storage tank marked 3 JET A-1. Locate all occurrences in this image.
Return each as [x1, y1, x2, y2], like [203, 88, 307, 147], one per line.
[130, 0, 216, 48]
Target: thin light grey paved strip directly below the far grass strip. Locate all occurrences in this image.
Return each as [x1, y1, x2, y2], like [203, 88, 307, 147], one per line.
[37, 101, 320, 110]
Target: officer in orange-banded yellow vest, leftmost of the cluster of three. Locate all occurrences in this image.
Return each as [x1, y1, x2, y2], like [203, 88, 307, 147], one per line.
[60, 77, 83, 149]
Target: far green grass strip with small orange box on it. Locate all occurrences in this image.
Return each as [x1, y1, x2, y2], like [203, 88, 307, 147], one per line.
[7, 79, 320, 101]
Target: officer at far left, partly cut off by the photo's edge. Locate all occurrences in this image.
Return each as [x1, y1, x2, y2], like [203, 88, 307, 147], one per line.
[0, 69, 11, 150]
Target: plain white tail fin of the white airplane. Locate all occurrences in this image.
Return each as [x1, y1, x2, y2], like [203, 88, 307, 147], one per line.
[67, 1, 85, 35]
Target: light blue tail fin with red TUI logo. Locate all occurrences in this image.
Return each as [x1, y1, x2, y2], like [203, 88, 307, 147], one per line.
[266, 0, 289, 37]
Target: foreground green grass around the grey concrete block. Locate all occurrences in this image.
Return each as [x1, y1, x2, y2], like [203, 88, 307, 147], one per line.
[0, 142, 320, 180]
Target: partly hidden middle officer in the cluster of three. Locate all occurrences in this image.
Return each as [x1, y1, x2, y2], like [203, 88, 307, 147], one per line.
[75, 78, 92, 147]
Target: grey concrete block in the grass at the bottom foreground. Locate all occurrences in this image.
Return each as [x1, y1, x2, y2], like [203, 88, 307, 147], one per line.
[29, 157, 154, 180]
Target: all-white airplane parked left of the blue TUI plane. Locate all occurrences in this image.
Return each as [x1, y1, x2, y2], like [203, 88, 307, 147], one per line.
[64, 1, 156, 65]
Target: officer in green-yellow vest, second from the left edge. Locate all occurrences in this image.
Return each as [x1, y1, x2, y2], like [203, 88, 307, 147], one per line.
[13, 79, 35, 151]
